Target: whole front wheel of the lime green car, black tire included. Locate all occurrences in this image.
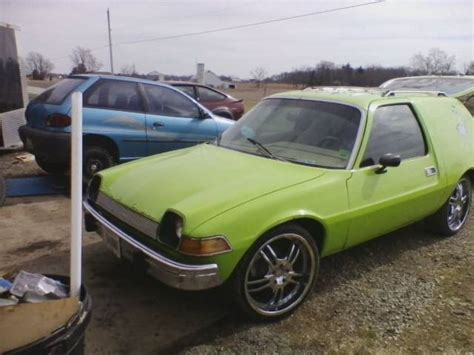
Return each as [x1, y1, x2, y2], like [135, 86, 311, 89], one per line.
[229, 224, 319, 321]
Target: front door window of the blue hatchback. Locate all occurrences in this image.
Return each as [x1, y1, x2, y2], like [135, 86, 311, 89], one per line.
[143, 85, 200, 118]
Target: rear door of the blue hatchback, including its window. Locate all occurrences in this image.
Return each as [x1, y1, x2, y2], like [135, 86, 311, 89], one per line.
[83, 79, 147, 161]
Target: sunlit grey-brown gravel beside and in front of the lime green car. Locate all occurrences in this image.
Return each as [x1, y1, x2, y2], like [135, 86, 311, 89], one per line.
[176, 214, 474, 354]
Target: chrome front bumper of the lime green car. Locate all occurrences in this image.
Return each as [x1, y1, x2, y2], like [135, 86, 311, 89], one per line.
[83, 201, 222, 290]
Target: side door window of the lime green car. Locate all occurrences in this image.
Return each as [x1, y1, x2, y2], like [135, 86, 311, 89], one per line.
[361, 104, 427, 167]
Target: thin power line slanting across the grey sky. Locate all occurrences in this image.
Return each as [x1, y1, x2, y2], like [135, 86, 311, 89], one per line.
[116, 0, 386, 45]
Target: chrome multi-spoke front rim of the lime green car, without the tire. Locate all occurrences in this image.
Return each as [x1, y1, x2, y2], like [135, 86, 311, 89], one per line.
[244, 233, 317, 316]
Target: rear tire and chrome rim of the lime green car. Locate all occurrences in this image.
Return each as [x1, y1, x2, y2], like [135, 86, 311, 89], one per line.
[426, 176, 472, 237]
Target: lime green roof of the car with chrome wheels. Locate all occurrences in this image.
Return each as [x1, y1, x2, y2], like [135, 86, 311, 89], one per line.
[267, 86, 456, 110]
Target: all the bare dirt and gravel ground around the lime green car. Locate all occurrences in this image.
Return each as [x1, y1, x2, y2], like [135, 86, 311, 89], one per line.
[0, 153, 474, 354]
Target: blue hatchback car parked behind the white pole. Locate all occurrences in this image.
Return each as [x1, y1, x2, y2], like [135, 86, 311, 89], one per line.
[20, 75, 234, 178]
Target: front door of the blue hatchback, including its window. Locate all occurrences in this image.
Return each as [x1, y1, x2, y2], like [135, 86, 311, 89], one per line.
[140, 84, 217, 155]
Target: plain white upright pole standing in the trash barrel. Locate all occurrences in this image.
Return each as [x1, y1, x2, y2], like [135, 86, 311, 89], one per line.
[70, 92, 82, 297]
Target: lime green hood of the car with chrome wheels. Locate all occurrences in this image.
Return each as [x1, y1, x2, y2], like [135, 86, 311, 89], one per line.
[100, 144, 324, 232]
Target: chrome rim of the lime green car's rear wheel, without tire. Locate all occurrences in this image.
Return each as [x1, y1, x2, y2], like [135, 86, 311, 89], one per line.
[448, 179, 471, 232]
